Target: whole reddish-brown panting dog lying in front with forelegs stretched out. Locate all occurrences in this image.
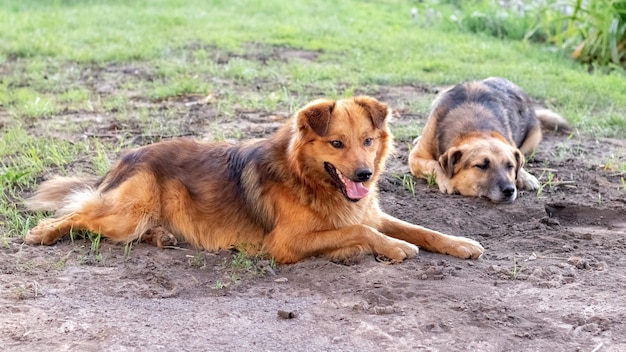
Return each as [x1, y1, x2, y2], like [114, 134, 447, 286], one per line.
[25, 97, 483, 263]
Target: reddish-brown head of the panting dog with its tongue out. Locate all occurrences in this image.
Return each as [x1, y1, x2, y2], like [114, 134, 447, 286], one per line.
[289, 96, 392, 202]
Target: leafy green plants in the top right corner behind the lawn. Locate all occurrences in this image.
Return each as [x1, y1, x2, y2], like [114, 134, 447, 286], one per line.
[422, 0, 626, 70]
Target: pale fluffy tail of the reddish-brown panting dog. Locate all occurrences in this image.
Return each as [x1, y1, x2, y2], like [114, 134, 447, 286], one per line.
[26, 177, 98, 216]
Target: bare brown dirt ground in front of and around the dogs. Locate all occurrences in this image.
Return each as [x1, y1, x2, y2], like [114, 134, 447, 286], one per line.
[0, 59, 626, 352]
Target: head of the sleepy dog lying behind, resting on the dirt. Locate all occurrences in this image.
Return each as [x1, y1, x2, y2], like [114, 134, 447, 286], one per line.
[439, 133, 524, 203]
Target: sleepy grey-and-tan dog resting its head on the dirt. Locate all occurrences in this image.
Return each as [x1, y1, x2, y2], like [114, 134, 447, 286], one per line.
[409, 77, 570, 202]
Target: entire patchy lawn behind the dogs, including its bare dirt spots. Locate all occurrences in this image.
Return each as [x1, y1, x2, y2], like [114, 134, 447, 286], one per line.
[0, 0, 626, 239]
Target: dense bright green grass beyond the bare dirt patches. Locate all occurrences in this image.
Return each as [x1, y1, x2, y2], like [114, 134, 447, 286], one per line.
[0, 1, 626, 126]
